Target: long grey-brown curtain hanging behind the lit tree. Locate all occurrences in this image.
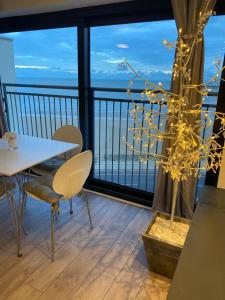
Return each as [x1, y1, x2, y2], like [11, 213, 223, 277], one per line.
[153, 0, 216, 218]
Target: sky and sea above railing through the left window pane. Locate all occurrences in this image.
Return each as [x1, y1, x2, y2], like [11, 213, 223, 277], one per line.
[2, 28, 78, 85]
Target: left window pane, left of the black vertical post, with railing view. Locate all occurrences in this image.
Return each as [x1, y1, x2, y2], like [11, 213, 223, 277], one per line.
[0, 28, 79, 138]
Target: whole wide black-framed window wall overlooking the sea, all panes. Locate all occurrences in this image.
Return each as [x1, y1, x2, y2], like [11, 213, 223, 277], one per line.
[0, 10, 225, 205]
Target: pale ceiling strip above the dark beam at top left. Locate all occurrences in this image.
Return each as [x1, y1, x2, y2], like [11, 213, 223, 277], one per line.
[0, 0, 132, 18]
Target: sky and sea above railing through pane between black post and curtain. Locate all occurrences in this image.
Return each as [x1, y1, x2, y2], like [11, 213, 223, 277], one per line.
[91, 21, 177, 88]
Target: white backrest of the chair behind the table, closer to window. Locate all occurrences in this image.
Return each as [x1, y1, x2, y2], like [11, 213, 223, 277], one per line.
[52, 125, 83, 159]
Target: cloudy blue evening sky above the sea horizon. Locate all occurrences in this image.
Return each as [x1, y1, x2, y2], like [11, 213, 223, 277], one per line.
[1, 16, 225, 81]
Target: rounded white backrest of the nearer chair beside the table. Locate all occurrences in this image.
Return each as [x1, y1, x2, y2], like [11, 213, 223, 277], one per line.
[53, 150, 92, 199]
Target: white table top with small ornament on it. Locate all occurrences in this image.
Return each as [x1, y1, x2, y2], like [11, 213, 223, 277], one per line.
[0, 135, 78, 176]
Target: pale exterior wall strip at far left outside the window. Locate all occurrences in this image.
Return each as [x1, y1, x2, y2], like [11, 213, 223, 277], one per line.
[0, 37, 16, 83]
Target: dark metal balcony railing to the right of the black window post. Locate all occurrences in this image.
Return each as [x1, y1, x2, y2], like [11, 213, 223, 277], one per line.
[93, 88, 217, 194]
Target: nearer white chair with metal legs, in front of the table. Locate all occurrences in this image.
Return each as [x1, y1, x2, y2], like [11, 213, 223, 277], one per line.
[23, 150, 93, 261]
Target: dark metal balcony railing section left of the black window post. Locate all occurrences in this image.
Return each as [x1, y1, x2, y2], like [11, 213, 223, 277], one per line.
[3, 84, 79, 138]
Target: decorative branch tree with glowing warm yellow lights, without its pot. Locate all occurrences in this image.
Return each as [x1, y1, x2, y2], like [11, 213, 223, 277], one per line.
[126, 7, 225, 228]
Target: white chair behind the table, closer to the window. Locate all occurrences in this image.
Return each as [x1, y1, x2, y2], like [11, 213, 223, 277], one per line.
[32, 125, 83, 175]
